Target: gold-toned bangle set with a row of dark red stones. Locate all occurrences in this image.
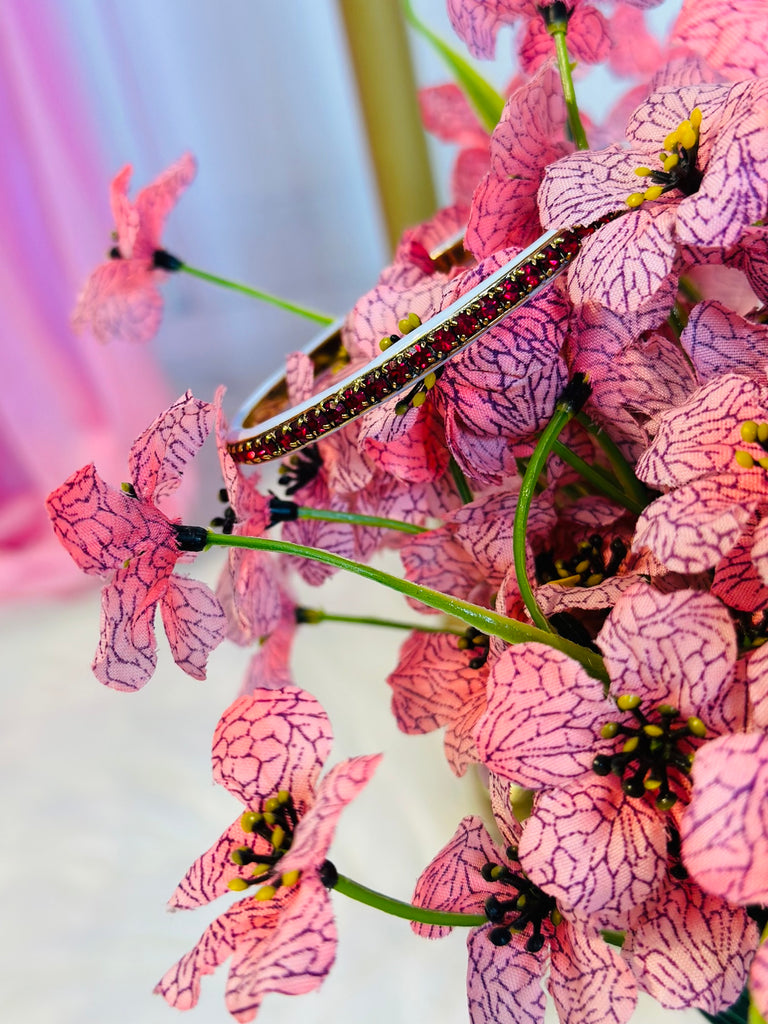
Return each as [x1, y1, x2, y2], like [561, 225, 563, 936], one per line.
[226, 222, 616, 466]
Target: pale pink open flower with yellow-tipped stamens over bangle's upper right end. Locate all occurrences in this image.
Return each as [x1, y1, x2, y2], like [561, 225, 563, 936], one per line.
[539, 80, 768, 313]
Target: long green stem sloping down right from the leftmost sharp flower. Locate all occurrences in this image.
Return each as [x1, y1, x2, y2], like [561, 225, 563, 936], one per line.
[198, 530, 608, 682]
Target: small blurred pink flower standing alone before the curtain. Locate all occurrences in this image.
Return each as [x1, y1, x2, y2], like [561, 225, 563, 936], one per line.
[72, 153, 196, 342]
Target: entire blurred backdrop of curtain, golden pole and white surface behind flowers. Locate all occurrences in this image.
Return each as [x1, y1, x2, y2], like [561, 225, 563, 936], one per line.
[0, 0, 700, 1024]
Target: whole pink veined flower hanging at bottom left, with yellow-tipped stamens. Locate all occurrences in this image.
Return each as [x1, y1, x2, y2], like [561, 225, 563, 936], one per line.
[155, 687, 381, 1021]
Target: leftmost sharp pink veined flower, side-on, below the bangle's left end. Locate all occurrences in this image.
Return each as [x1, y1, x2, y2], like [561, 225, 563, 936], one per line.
[46, 391, 224, 690]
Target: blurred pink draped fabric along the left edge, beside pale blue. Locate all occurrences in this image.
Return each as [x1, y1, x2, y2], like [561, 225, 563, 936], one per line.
[0, 0, 168, 599]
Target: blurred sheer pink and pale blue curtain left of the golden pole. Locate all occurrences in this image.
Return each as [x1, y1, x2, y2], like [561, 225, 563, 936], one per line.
[0, 0, 386, 596]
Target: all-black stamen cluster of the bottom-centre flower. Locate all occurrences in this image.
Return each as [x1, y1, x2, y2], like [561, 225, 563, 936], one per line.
[480, 846, 562, 953]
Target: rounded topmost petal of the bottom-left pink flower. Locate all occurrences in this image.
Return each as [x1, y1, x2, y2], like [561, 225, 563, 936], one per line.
[213, 687, 333, 814]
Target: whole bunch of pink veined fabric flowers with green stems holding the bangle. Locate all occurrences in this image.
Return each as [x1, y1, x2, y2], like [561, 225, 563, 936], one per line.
[48, 0, 768, 1024]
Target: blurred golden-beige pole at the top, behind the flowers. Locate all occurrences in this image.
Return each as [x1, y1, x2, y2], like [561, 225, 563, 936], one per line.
[339, 0, 436, 248]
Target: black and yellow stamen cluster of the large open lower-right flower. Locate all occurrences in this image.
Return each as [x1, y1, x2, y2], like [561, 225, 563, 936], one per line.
[592, 693, 707, 811]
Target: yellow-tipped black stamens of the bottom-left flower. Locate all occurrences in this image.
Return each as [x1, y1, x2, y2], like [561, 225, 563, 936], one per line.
[227, 790, 299, 900]
